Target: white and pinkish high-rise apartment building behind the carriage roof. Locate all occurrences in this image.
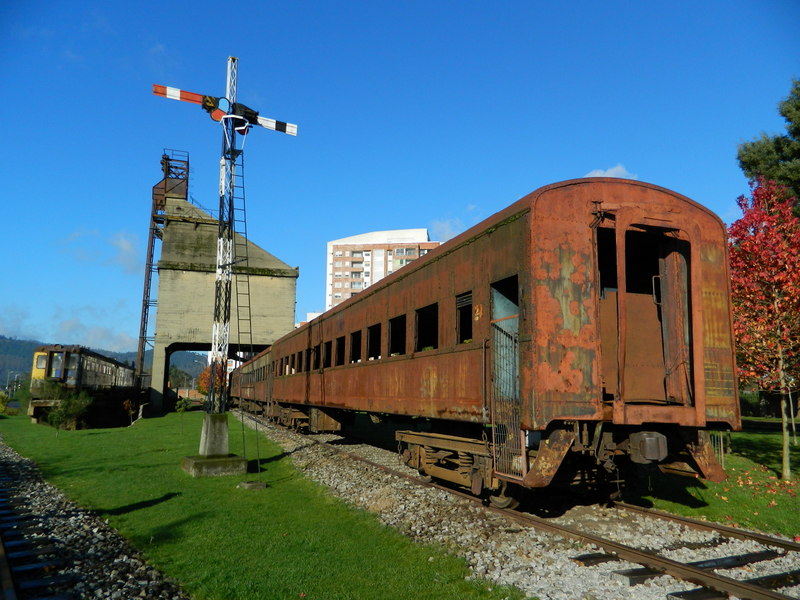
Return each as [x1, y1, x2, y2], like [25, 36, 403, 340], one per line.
[325, 229, 440, 310]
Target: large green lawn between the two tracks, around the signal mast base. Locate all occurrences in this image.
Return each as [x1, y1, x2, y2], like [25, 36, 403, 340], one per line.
[0, 412, 523, 600]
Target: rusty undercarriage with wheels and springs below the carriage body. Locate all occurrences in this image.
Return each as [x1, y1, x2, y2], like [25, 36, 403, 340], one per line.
[231, 400, 725, 508]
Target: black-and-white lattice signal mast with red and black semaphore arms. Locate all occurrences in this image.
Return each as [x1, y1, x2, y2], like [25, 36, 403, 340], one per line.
[153, 56, 297, 413]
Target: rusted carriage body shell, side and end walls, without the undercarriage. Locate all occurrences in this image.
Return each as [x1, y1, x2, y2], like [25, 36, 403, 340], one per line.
[230, 179, 739, 430]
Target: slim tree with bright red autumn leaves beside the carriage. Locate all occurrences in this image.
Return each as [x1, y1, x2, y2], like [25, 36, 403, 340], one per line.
[728, 178, 800, 480]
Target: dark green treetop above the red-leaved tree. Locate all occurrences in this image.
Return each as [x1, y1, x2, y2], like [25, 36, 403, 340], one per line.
[738, 80, 800, 199]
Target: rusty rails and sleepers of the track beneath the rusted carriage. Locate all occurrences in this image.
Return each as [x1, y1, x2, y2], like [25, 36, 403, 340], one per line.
[238, 415, 800, 600]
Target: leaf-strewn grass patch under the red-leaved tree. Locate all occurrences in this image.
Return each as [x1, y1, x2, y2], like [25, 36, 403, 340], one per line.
[642, 432, 800, 537]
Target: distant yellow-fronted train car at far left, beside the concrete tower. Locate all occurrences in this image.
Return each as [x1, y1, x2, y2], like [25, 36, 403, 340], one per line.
[28, 344, 135, 421]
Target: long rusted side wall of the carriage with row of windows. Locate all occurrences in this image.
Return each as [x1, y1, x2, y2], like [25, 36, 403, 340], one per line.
[266, 209, 530, 422]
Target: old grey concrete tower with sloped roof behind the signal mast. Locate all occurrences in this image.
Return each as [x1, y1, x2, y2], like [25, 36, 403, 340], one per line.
[150, 189, 299, 409]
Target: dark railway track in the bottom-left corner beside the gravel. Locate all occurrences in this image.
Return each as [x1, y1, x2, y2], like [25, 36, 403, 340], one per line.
[0, 465, 74, 600]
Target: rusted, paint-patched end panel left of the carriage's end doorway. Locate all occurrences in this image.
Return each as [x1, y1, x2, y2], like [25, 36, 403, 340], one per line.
[523, 186, 602, 429]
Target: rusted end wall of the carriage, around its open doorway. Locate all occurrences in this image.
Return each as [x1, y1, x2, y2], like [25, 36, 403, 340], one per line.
[524, 179, 739, 428]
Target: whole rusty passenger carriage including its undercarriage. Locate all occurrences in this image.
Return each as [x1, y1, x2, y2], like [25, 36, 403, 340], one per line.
[232, 179, 740, 504]
